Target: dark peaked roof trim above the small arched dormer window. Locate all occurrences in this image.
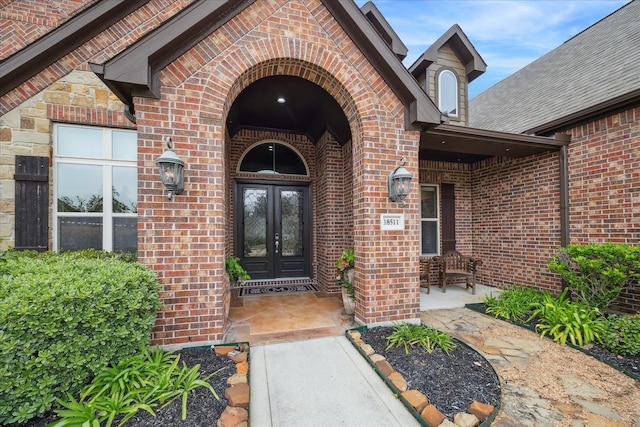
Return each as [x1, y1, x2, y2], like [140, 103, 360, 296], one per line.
[409, 24, 487, 83]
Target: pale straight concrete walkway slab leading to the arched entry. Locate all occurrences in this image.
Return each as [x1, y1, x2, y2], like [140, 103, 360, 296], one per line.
[249, 336, 419, 427]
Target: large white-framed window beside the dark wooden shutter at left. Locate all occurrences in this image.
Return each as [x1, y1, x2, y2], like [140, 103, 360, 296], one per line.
[53, 124, 138, 253]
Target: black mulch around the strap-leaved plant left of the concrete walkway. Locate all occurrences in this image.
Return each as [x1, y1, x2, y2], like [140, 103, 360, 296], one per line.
[27, 347, 235, 427]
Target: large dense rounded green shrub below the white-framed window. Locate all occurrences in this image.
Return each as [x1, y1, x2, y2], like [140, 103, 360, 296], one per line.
[0, 252, 160, 424]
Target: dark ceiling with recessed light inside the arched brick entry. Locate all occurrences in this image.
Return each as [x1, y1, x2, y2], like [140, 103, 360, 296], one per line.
[227, 76, 351, 144]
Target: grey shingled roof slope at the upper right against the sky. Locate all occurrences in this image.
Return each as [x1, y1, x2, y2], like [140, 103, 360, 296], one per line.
[469, 0, 640, 133]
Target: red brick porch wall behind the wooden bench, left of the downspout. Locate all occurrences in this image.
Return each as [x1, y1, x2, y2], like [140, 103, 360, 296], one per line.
[472, 152, 560, 290]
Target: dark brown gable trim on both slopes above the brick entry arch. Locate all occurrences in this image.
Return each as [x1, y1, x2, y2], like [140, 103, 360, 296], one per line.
[92, 0, 442, 127]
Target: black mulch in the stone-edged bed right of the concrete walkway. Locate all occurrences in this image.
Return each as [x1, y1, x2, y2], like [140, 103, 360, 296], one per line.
[362, 327, 500, 420]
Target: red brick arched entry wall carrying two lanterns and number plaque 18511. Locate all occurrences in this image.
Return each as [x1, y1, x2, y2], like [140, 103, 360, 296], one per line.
[135, 1, 419, 345]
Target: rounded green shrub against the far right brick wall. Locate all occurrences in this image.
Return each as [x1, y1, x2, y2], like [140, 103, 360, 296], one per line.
[547, 243, 640, 311]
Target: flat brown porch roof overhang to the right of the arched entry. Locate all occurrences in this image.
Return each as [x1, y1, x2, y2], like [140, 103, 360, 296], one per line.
[420, 124, 569, 163]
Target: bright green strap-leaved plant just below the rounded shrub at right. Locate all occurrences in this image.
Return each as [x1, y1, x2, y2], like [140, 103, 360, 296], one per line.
[532, 288, 606, 346]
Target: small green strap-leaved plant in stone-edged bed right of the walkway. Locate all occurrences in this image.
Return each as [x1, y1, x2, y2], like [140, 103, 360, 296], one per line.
[386, 323, 456, 354]
